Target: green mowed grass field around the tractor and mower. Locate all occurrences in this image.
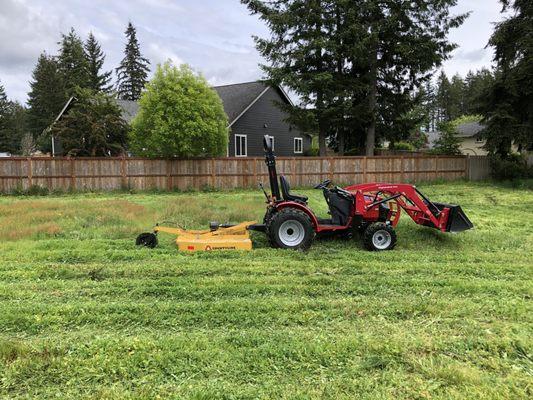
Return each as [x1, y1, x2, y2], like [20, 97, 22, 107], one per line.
[0, 182, 533, 399]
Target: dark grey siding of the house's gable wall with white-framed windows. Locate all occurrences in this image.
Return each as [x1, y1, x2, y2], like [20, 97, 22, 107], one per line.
[228, 88, 311, 157]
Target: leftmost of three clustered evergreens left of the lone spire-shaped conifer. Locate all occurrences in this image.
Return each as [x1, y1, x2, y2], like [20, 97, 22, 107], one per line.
[28, 53, 68, 147]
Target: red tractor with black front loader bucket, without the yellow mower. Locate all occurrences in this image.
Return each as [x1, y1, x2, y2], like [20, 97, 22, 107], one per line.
[248, 137, 473, 251]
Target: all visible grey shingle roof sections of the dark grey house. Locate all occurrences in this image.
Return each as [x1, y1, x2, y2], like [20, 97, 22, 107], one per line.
[117, 81, 291, 126]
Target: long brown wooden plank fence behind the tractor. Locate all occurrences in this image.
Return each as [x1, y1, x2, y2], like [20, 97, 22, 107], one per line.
[0, 156, 477, 193]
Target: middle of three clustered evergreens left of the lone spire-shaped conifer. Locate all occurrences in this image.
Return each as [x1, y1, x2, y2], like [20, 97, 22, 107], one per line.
[57, 28, 90, 96]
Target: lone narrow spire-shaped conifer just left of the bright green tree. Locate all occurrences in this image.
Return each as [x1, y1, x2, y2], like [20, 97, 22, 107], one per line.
[116, 22, 150, 101]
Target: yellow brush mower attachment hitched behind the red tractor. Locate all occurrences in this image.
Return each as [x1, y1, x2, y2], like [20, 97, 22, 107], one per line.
[136, 222, 255, 252]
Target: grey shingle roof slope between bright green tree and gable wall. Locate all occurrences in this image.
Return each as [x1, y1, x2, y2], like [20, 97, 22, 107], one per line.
[213, 82, 267, 124]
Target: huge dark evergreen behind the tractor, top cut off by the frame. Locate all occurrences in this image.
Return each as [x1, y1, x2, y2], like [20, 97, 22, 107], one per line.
[242, 0, 465, 154]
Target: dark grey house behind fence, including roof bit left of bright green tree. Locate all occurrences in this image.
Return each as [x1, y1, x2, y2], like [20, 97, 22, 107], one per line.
[117, 82, 312, 157]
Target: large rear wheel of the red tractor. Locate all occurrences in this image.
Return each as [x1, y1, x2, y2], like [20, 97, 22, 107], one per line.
[267, 208, 315, 250]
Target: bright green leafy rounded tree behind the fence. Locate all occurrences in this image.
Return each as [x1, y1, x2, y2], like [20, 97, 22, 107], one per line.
[130, 62, 228, 157]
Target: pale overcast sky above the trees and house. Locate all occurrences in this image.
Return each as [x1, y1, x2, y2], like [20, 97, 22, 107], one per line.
[0, 0, 501, 102]
